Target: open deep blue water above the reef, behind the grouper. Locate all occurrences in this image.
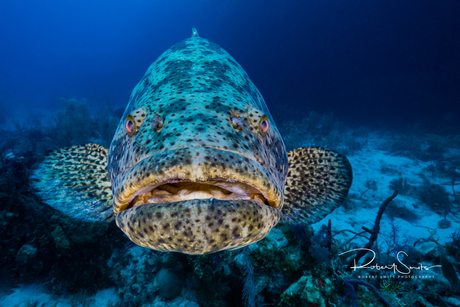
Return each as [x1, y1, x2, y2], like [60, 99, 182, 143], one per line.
[0, 0, 460, 131]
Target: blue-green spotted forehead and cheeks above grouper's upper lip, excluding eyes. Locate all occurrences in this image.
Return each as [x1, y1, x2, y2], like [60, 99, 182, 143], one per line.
[108, 37, 287, 185]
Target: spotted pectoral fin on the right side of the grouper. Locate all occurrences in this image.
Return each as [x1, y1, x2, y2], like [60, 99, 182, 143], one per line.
[281, 147, 353, 224]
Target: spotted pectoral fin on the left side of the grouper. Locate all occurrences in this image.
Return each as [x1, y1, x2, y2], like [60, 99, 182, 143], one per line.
[30, 144, 114, 222]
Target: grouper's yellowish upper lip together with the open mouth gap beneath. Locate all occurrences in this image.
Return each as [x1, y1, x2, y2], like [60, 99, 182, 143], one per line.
[113, 147, 283, 213]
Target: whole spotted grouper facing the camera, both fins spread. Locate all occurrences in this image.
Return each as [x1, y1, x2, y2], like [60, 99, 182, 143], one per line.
[30, 29, 353, 255]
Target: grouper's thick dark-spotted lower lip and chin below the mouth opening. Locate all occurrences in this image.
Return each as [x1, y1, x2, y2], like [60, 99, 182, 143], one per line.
[115, 199, 281, 255]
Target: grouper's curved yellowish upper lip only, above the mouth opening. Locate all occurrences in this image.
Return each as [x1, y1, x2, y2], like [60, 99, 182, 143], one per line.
[113, 147, 284, 214]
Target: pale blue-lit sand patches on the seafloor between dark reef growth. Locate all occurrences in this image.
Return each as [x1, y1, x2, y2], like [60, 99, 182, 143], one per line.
[0, 132, 460, 307]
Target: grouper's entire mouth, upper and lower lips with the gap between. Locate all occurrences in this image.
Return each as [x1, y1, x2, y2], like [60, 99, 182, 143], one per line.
[113, 147, 284, 254]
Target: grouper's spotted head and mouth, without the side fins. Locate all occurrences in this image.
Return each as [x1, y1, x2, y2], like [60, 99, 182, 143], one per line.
[108, 37, 288, 254]
